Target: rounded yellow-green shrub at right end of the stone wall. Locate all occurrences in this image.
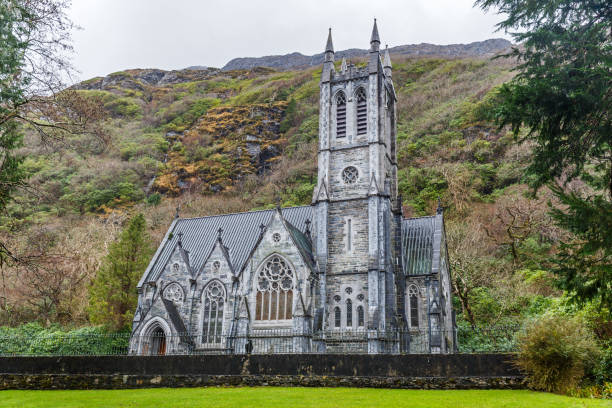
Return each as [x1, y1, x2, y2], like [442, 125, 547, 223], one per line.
[517, 315, 599, 392]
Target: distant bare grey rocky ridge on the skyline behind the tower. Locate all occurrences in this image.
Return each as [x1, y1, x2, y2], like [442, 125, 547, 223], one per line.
[221, 38, 512, 71]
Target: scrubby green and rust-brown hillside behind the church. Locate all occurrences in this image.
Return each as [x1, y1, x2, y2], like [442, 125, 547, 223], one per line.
[0, 49, 558, 324]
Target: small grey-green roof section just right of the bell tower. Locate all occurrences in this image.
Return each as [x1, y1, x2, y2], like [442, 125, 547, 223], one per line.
[402, 216, 441, 275]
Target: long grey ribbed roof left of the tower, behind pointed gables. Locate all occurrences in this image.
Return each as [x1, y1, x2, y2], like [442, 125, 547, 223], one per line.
[138, 205, 313, 287]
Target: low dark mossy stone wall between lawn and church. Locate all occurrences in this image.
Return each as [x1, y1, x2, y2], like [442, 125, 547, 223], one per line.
[0, 354, 525, 389]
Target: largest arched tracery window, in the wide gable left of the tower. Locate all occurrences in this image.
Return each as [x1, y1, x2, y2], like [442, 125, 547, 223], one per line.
[255, 255, 295, 320]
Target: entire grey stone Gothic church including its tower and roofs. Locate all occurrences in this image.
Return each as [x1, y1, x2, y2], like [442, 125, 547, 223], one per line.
[130, 21, 456, 354]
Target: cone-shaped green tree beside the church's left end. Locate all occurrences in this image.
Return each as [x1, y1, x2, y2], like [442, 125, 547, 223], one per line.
[89, 214, 154, 330]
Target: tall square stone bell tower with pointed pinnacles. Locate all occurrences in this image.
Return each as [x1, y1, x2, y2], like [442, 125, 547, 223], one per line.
[313, 20, 401, 348]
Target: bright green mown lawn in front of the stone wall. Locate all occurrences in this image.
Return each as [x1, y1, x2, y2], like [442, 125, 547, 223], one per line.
[0, 387, 612, 408]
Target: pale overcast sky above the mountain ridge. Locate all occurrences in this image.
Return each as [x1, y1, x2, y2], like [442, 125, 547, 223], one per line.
[69, 0, 510, 80]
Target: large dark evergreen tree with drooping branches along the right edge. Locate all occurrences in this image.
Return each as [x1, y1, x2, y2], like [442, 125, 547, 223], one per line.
[476, 0, 612, 307]
